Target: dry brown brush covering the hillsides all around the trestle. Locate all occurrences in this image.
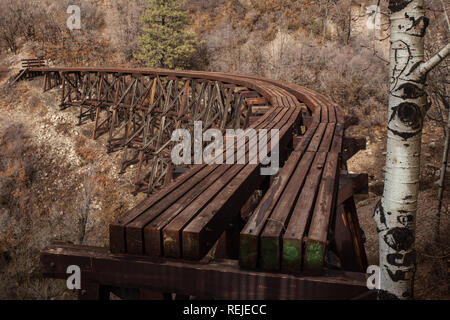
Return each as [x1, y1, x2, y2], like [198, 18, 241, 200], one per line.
[0, 0, 450, 299]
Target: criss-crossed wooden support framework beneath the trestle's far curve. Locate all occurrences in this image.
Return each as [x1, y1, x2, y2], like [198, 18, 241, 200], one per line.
[40, 69, 266, 194]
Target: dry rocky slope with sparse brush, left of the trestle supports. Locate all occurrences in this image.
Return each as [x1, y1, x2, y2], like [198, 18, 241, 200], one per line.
[0, 69, 142, 299]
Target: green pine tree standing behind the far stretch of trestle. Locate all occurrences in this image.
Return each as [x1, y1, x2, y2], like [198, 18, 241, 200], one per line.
[136, 0, 197, 69]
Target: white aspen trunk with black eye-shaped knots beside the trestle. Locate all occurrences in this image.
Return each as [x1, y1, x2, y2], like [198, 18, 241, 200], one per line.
[374, 0, 450, 299]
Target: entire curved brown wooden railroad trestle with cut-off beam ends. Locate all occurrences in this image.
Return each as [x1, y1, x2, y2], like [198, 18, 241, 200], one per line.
[17, 67, 370, 299]
